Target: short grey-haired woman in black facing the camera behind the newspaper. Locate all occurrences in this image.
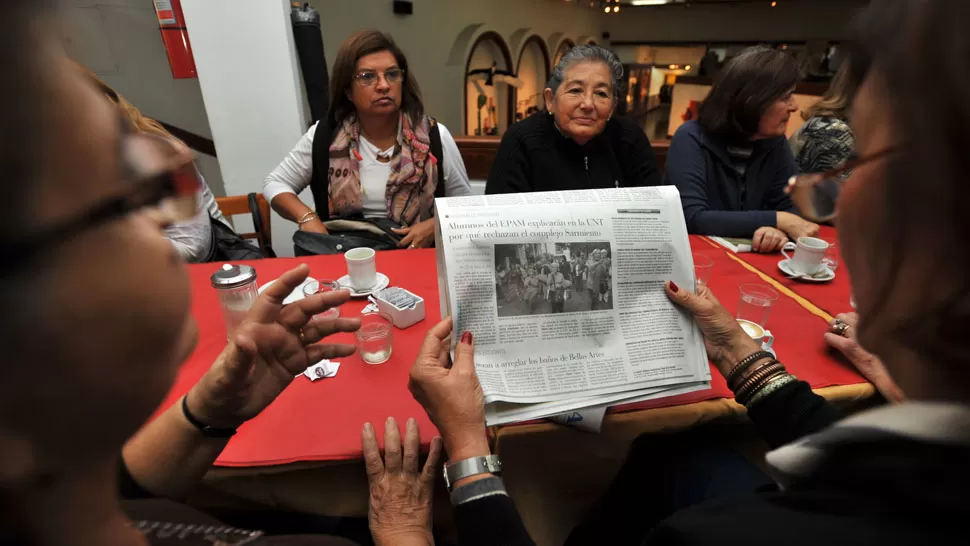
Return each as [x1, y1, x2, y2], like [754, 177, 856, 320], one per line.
[485, 45, 661, 194]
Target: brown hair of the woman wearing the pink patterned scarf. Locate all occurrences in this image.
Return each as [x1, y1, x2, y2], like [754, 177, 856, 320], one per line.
[327, 29, 424, 131]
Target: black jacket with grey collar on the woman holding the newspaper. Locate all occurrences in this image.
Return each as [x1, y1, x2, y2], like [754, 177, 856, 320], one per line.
[455, 382, 970, 546]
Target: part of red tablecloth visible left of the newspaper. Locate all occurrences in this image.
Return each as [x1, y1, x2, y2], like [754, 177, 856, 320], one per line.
[162, 250, 441, 466]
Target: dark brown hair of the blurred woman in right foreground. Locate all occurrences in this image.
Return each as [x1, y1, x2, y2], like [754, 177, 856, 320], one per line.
[853, 0, 970, 382]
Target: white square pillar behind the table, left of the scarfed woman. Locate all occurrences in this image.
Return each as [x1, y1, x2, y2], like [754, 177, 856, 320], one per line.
[182, 0, 310, 255]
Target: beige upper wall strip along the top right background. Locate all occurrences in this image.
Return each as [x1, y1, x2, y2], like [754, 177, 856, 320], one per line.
[605, 0, 866, 43]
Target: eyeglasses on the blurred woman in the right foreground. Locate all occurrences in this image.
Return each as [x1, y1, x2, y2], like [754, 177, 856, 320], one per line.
[785, 147, 897, 222]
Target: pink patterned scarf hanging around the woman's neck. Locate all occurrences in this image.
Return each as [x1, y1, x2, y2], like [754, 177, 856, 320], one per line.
[329, 112, 438, 226]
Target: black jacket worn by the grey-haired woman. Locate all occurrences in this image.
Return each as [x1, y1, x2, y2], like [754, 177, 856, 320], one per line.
[485, 112, 661, 194]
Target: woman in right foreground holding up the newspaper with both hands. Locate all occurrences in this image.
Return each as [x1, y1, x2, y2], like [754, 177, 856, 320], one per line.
[402, 0, 970, 546]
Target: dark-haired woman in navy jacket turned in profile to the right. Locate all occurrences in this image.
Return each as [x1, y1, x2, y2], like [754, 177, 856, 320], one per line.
[664, 47, 819, 252]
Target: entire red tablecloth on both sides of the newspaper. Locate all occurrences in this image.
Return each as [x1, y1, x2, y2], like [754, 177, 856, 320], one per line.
[163, 237, 864, 467]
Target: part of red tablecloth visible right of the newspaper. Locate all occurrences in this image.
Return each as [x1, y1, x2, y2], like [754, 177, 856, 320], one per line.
[612, 236, 865, 412]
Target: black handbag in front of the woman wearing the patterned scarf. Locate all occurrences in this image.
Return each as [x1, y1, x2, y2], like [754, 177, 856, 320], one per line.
[293, 218, 401, 256]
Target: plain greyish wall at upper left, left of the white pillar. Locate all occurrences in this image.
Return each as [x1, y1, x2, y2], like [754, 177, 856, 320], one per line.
[58, 0, 225, 195]
